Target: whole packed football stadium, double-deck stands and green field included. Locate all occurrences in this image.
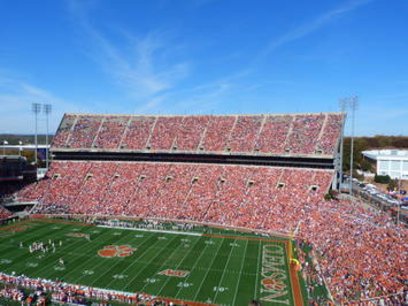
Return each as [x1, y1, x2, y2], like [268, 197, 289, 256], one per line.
[0, 113, 408, 306]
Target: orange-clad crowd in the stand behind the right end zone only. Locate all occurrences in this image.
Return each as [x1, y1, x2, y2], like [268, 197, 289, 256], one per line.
[299, 200, 408, 305]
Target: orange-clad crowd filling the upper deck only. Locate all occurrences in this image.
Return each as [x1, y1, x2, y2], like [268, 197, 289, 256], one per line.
[53, 113, 343, 155]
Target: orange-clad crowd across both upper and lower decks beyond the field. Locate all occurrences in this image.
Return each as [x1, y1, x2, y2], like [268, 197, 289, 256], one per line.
[6, 113, 408, 305]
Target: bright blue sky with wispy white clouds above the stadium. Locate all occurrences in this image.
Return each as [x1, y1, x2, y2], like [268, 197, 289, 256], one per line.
[0, 0, 408, 135]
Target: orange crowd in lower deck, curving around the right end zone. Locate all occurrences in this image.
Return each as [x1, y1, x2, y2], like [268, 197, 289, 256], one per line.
[14, 161, 408, 302]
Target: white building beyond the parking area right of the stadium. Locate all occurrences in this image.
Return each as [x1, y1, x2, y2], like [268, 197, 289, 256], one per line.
[362, 150, 408, 180]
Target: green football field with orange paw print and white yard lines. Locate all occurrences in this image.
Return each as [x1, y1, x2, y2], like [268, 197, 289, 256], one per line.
[0, 219, 304, 305]
